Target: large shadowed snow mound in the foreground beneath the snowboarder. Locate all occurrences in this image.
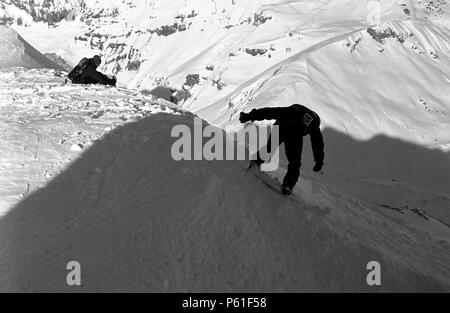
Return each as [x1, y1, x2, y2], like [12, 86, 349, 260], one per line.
[0, 113, 450, 292]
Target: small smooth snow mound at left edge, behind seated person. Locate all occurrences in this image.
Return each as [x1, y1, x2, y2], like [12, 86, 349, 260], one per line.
[0, 25, 64, 70]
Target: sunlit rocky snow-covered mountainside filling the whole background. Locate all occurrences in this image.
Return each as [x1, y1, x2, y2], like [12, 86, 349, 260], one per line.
[3, 0, 450, 142]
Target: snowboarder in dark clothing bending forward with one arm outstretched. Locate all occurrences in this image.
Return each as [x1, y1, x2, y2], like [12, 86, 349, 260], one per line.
[239, 104, 324, 194]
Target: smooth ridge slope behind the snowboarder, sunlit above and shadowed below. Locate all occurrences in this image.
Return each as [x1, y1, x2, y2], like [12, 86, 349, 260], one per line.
[203, 16, 450, 229]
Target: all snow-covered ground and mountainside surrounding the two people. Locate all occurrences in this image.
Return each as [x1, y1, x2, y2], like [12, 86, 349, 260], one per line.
[0, 0, 450, 292]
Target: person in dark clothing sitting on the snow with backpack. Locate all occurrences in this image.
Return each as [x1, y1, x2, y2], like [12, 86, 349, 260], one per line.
[67, 55, 117, 86]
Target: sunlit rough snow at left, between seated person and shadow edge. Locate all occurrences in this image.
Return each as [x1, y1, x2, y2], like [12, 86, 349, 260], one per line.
[0, 68, 179, 216]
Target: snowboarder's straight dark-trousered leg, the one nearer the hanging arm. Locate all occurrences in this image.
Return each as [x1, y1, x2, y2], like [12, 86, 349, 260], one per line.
[282, 135, 303, 193]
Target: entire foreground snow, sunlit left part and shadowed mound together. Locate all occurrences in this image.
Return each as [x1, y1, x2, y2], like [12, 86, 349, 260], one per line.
[0, 68, 450, 292]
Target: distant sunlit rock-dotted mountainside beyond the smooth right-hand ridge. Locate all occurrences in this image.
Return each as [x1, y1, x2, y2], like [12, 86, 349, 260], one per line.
[4, 0, 422, 87]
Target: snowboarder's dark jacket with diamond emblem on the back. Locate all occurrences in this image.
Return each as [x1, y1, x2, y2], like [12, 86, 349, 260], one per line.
[248, 104, 324, 163]
